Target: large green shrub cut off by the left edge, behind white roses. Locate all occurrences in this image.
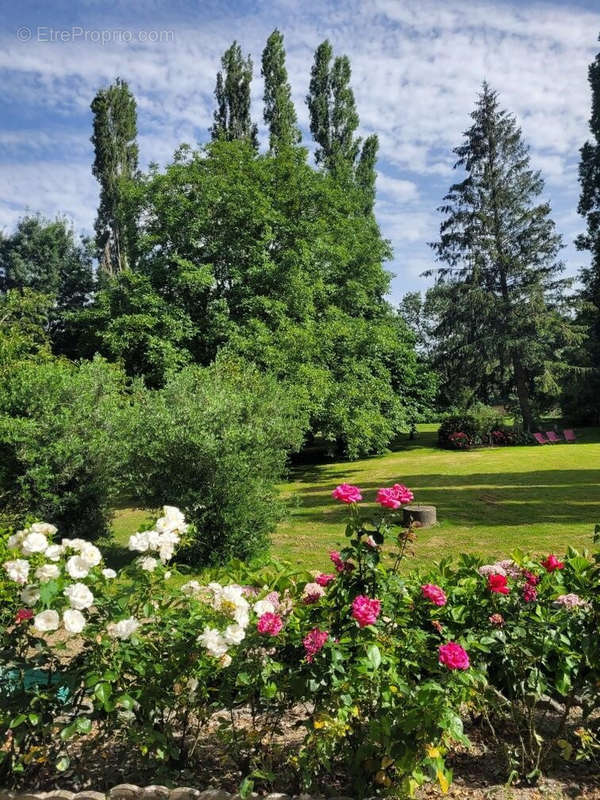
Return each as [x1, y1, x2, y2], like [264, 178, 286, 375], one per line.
[0, 359, 125, 537]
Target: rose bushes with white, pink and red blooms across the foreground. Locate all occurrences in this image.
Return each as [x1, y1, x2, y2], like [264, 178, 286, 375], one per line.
[0, 494, 600, 795]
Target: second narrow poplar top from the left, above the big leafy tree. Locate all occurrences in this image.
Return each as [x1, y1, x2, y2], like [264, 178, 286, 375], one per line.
[210, 41, 258, 149]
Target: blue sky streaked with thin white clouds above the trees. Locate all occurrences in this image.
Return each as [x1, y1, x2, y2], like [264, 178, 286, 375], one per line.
[0, 0, 600, 302]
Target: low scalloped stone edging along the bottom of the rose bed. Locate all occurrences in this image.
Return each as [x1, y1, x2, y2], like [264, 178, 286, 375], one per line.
[0, 783, 352, 800]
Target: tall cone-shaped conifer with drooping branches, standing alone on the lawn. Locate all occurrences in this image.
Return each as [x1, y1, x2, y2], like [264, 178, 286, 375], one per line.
[428, 83, 568, 430]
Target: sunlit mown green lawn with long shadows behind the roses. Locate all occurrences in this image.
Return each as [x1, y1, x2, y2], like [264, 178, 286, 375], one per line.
[114, 425, 600, 569]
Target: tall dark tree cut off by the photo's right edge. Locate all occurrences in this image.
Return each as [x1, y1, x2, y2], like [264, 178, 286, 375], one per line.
[568, 36, 600, 422]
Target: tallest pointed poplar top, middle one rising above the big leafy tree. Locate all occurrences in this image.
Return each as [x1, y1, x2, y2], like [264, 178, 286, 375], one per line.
[261, 28, 302, 153]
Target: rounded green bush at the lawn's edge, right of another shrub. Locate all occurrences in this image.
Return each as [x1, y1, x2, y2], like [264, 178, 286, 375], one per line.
[128, 360, 307, 565]
